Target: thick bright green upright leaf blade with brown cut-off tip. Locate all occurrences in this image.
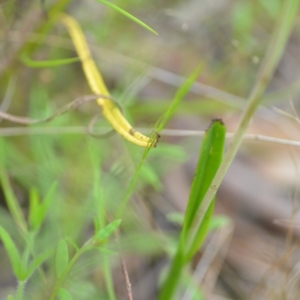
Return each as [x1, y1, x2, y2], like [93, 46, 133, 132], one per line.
[158, 120, 225, 300]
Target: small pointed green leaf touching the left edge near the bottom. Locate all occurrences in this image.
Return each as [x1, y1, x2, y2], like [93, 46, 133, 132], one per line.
[0, 226, 22, 280]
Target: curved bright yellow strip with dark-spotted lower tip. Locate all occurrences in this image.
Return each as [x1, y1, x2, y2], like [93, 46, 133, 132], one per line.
[61, 14, 158, 147]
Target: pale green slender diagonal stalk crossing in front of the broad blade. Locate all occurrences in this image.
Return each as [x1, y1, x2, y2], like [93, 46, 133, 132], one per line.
[189, 0, 300, 248]
